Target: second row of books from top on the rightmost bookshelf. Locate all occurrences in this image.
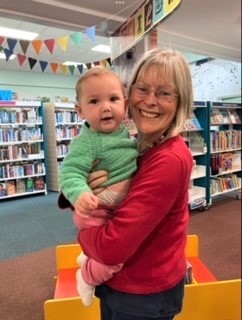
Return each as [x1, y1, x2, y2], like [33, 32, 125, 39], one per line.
[210, 130, 241, 152]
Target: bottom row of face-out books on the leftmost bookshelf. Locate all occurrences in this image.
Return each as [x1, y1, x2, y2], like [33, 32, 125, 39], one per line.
[0, 177, 46, 197]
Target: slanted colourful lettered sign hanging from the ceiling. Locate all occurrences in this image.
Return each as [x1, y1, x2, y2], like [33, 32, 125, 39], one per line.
[111, 0, 181, 61]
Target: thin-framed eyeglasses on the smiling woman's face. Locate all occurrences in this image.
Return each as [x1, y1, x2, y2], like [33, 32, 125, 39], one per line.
[132, 83, 177, 102]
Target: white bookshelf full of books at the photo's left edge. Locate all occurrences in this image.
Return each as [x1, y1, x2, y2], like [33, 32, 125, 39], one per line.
[0, 101, 47, 200]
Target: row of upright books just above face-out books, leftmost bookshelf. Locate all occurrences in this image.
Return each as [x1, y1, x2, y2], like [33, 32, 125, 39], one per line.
[0, 161, 45, 179]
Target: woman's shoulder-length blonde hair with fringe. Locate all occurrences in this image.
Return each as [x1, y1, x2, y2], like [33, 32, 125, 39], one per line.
[128, 48, 193, 137]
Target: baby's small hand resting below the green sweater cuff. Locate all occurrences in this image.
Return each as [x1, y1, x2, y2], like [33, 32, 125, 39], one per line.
[74, 192, 99, 216]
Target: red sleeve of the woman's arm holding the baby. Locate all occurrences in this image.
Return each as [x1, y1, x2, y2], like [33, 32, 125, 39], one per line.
[78, 138, 192, 265]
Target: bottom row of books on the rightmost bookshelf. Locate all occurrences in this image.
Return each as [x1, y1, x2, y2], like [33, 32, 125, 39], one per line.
[210, 174, 241, 195]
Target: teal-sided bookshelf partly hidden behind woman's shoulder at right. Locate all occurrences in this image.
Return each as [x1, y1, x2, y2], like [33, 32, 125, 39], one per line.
[182, 101, 210, 211]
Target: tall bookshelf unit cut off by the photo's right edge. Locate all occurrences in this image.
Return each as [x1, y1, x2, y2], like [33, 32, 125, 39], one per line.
[209, 102, 241, 199]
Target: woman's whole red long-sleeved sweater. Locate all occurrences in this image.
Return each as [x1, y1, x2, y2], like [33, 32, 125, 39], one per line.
[78, 136, 192, 294]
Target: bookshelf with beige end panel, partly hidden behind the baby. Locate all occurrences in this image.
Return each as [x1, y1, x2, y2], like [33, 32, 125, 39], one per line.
[43, 102, 83, 192]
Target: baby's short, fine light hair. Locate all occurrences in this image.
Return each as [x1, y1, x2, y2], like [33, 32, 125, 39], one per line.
[76, 66, 125, 101]
